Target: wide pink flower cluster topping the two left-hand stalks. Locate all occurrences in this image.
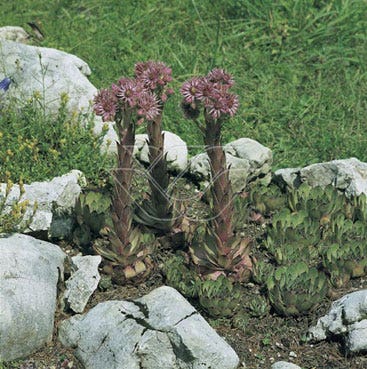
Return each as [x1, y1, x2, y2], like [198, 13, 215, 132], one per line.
[93, 61, 173, 123]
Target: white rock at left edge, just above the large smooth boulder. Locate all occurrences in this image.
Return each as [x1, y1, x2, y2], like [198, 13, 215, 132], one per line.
[0, 170, 86, 239]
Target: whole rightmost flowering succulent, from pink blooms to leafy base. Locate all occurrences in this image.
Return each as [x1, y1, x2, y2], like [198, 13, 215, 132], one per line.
[180, 69, 252, 281]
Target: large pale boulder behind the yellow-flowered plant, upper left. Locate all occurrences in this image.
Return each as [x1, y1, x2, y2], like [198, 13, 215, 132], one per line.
[0, 38, 117, 152]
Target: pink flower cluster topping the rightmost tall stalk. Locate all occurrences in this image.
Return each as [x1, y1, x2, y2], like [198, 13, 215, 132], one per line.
[180, 69, 239, 120]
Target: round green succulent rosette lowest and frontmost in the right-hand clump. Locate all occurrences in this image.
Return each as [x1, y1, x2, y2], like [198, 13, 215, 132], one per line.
[266, 262, 328, 316]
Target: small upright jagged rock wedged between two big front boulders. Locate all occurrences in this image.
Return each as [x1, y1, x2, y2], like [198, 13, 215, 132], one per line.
[63, 255, 102, 313]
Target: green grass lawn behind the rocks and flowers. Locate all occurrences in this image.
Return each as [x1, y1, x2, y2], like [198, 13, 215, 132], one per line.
[0, 0, 367, 169]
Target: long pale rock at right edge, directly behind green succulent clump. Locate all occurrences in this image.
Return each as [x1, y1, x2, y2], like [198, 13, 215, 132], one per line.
[274, 158, 367, 196]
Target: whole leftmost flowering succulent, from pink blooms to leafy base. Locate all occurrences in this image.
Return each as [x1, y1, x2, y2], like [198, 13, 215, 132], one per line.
[94, 71, 159, 280]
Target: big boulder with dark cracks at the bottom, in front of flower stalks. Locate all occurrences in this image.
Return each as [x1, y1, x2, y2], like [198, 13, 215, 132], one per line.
[59, 286, 239, 369]
